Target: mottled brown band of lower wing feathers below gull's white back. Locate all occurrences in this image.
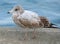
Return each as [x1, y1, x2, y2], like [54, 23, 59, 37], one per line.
[19, 19, 43, 28]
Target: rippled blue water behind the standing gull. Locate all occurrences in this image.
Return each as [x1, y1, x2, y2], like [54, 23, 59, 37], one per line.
[0, 0, 60, 27]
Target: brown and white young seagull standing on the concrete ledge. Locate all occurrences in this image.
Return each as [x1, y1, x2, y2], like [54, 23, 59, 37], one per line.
[8, 5, 56, 39]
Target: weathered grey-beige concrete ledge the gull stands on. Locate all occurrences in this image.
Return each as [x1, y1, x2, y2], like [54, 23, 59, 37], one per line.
[0, 28, 60, 44]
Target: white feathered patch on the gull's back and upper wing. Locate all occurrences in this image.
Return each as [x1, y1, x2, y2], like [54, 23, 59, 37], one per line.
[17, 10, 40, 21]
